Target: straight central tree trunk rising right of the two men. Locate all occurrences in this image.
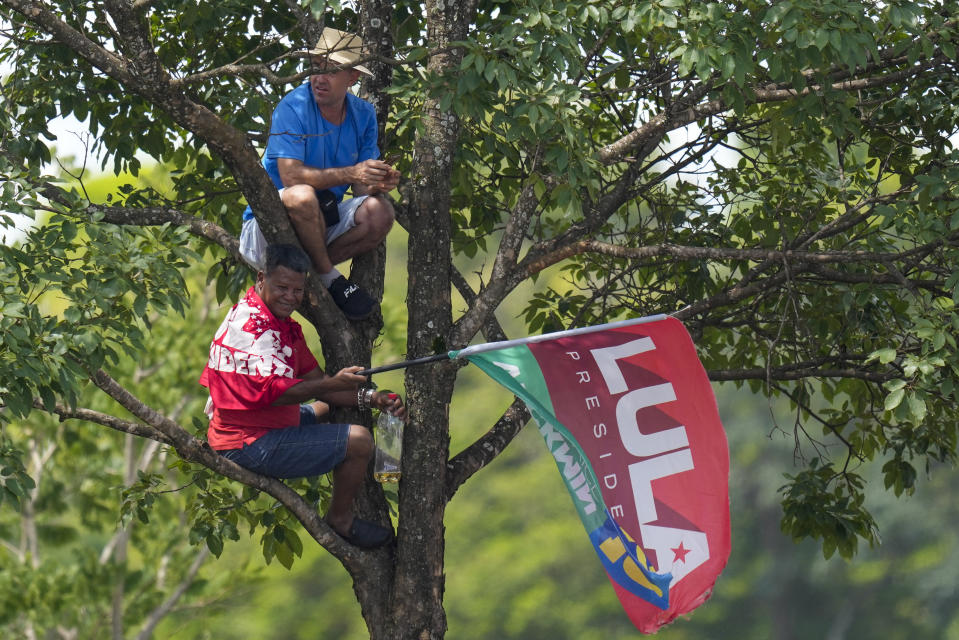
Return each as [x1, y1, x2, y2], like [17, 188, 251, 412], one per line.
[378, 1, 472, 640]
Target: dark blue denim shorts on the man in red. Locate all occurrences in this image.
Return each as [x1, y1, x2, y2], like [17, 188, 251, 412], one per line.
[219, 405, 350, 478]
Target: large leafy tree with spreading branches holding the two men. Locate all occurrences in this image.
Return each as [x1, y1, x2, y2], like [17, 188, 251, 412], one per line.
[0, 0, 959, 637]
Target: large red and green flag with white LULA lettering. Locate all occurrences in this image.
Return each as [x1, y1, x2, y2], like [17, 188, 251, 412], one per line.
[450, 316, 730, 633]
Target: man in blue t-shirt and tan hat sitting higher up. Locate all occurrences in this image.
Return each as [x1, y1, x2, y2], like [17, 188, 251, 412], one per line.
[240, 28, 400, 320]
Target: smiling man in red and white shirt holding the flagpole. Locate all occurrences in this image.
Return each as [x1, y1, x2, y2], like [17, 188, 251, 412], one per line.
[200, 245, 406, 548]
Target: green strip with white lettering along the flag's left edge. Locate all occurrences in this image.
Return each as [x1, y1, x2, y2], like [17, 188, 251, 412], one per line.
[464, 345, 606, 533]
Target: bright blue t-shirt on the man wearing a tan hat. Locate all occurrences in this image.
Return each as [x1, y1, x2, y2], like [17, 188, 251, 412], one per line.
[243, 82, 380, 220]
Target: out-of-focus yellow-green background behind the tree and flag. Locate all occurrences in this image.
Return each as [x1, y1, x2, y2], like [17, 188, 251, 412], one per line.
[9, 170, 959, 640]
